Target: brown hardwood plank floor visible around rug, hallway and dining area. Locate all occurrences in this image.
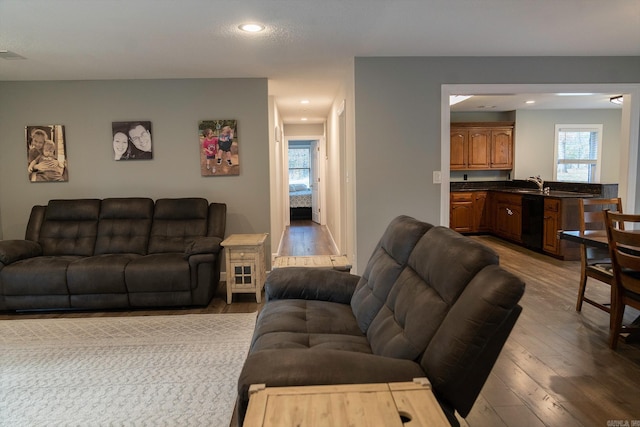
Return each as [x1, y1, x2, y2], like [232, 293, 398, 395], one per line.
[0, 224, 640, 427]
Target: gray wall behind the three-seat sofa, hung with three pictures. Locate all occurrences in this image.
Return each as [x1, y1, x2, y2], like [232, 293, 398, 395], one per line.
[0, 79, 270, 253]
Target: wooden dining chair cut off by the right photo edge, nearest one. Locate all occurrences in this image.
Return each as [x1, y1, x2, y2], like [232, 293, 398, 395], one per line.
[605, 211, 640, 349]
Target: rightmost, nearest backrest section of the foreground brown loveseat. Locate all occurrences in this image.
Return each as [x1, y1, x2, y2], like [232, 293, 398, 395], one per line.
[420, 265, 525, 417]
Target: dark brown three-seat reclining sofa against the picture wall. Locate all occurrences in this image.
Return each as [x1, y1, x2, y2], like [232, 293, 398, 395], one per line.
[0, 198, 226, 310]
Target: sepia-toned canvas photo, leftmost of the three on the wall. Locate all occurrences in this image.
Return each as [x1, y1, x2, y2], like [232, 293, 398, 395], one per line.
[25, 125, 69, 182]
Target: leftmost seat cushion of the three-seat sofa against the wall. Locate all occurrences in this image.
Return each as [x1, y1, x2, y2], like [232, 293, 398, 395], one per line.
[0, 256, 81, 296]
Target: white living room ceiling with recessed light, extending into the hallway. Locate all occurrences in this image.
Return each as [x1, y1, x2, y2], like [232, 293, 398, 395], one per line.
[0, 0, 640, 123]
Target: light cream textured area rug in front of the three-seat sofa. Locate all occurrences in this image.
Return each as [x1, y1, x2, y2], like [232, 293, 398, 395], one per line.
[0, 313, 256, 427]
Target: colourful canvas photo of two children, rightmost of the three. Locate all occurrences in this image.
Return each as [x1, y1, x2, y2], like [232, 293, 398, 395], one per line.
[198, 120, 240, 176]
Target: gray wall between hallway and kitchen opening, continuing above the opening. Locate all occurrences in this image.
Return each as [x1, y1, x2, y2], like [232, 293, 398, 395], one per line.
[354, 57, 640, 272]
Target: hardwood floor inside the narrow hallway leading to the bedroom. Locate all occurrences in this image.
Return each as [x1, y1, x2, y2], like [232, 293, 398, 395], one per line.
[278, 220, 339, 256]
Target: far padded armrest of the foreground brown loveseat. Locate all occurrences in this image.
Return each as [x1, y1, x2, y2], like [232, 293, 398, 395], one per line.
[264, 267, 360, 304]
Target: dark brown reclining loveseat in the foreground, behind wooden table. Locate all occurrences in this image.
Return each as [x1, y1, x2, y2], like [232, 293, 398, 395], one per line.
[238, 216, 524, 425]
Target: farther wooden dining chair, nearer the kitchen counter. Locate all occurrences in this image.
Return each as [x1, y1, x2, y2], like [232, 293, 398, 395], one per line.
[576, 197, 622, 313]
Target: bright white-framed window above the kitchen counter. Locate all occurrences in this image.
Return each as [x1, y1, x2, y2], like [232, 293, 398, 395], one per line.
[553, 125, 602, 182]
